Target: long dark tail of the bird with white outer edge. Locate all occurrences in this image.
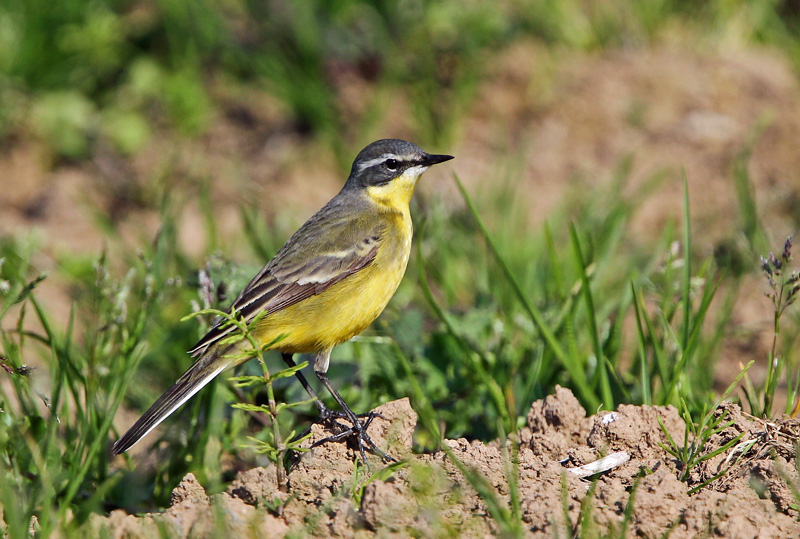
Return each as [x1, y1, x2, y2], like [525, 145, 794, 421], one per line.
[111, 347, 234, 455]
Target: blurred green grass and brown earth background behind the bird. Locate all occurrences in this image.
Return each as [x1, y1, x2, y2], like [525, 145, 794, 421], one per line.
[0, 0, 800, 536]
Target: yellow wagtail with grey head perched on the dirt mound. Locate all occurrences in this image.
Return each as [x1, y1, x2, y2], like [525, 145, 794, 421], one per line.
[112, 139, 452, 458]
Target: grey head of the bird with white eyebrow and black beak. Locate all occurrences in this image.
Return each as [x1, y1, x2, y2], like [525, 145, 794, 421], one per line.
[345, 139, 453, 189]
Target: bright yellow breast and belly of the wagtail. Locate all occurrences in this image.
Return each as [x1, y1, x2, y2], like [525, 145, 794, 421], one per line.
[256, 211, 412, 354]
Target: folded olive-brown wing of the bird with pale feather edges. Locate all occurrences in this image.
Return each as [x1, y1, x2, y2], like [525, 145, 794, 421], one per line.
[189, 202, 383, 356]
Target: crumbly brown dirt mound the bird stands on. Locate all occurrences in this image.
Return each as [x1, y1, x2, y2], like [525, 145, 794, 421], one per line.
[91, 387, 800, 539]
